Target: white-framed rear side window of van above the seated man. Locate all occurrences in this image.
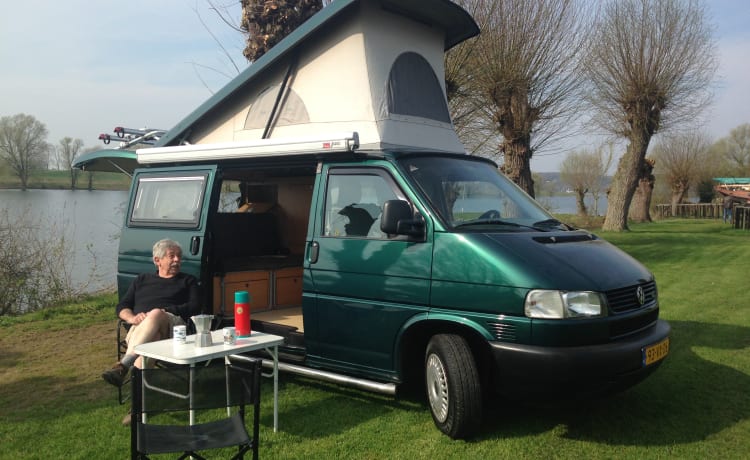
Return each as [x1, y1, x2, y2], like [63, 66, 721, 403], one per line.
[129, 175, 206, 228]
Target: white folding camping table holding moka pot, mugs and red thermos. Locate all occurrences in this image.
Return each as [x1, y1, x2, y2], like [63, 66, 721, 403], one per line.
[135, 330, 284, 432]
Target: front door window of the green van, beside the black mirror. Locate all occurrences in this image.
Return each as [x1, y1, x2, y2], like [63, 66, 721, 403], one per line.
[323, 174, 397, 239]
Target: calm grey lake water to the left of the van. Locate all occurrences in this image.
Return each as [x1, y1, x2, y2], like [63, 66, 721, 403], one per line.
[0, 190, 128, 292]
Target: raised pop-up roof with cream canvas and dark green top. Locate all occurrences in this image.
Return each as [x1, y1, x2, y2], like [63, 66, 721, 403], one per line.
[75, 0, 479, 170]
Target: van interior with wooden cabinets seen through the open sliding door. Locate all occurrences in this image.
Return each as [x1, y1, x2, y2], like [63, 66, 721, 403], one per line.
[206, 164, 316, 343]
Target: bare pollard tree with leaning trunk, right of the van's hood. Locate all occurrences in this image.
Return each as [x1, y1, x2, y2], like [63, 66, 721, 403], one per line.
[585, 0, 717, 231]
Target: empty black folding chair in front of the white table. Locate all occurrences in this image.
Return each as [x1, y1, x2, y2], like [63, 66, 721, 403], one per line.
[130, 360, 261, 460]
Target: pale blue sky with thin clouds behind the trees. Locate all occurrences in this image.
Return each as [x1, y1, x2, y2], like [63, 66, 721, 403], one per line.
[0, 0, 750, 172]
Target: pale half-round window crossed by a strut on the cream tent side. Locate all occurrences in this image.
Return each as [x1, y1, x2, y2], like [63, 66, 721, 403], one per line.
[245, 85, 310, 129]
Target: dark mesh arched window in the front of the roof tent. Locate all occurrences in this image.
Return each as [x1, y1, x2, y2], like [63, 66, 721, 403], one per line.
[387, 52, 451, 123]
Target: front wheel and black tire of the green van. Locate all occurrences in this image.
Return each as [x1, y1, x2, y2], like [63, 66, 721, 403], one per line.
[425, 334, 482, 439]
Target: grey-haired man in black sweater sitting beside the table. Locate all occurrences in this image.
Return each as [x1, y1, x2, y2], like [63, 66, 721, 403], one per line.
[102, 239, 200, 423]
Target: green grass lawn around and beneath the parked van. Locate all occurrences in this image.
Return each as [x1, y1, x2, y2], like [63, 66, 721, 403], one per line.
[0, 220, 750, 460]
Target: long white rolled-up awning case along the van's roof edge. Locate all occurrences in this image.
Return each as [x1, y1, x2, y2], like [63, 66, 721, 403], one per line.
[136, 132, 359, 164]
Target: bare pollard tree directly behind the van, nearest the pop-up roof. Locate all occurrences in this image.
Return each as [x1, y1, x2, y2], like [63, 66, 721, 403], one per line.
[459, 0, 591, 196]
